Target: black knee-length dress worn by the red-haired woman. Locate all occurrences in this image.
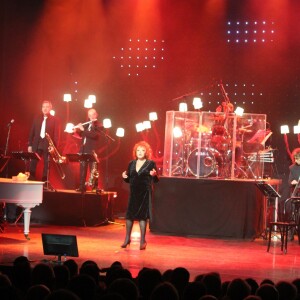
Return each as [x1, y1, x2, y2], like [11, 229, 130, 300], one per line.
[124, 160, 158, 220]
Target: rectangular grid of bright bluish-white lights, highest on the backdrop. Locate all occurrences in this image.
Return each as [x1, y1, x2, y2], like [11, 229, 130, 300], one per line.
[226, 20, 276, 44]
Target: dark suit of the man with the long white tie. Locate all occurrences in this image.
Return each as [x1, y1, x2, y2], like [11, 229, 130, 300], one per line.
[28, 114, 59, 181]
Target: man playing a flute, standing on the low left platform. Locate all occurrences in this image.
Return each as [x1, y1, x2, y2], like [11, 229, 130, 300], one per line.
[73, 108, 103, 193]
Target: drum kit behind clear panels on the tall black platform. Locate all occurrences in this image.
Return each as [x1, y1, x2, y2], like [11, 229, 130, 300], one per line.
[172, 125, 255, 178]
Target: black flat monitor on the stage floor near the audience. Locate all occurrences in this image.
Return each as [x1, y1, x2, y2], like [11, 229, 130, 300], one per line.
[42, 233, 79, 262]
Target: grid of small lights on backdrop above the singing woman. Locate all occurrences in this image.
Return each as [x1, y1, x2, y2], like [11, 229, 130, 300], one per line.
[113, 38, 165, 77]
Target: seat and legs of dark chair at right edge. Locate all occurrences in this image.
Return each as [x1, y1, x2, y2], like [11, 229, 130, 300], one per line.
[267, 221, 300, 254]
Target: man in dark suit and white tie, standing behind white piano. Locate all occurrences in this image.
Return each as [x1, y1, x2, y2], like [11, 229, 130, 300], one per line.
[28, 100, 60, 181]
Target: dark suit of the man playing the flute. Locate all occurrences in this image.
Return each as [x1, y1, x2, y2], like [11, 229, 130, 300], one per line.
[79, 121, 103, 190]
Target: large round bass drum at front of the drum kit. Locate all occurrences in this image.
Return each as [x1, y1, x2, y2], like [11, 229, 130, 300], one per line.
[188, 148, 222, 177]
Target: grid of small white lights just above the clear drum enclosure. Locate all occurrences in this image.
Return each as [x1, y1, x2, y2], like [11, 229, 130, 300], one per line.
[199, 83, 264, 111]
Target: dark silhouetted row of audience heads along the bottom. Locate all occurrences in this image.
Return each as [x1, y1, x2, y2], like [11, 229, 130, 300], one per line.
[0, 256, 300, 300]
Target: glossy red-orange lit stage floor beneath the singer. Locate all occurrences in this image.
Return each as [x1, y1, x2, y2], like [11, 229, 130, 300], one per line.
[0, 219, 300, 282]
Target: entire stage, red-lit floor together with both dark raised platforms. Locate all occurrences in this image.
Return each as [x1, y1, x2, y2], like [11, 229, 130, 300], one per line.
[0, 178, 300, 282]
